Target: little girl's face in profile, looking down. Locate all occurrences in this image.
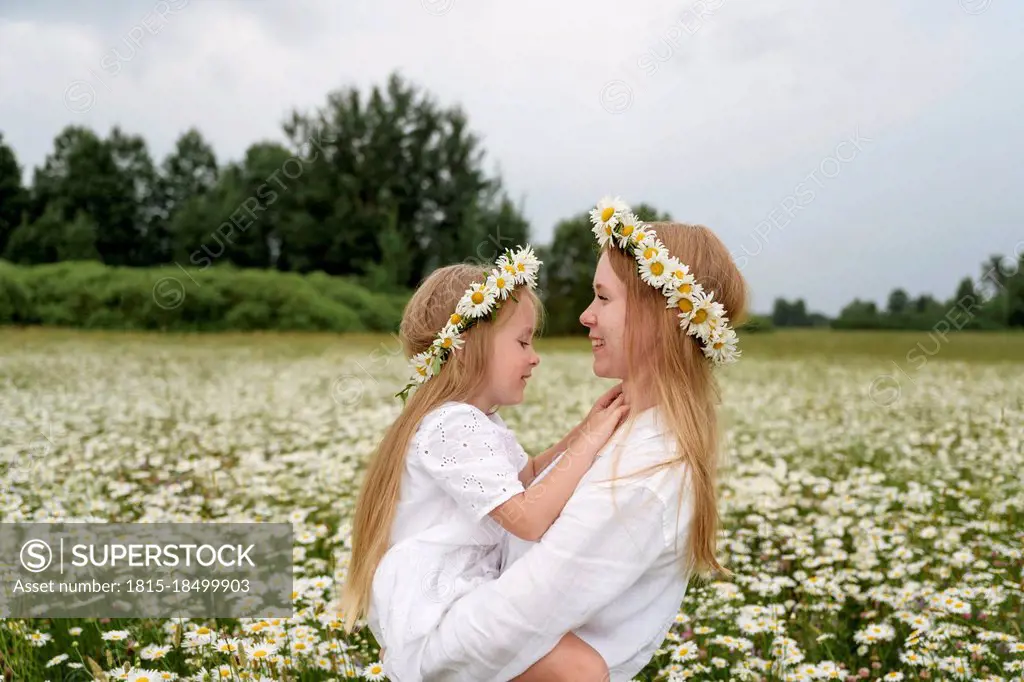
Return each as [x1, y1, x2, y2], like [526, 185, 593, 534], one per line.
[482, 297, 541, 407]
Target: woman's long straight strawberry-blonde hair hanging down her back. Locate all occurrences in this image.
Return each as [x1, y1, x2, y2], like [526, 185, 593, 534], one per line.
[605, 222, 746, 573]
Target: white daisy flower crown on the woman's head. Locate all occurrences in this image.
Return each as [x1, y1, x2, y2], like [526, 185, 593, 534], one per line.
[590, 197, 740, 365]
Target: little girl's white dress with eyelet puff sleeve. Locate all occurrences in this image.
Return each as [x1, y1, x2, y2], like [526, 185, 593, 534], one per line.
[367, 401, 528, 682]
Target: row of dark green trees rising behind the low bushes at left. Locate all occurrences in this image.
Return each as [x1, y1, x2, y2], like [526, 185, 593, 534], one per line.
[0, 74, 528, 290]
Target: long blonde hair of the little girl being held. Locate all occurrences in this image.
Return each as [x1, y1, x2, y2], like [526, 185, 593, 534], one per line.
[340, 263, 543, 632]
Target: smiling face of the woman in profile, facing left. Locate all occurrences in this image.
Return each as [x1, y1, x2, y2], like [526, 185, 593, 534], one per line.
[580, 253, 627, 379]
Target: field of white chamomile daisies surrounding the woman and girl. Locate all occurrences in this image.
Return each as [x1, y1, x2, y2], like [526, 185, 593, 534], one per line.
[0, 330, 1024, 681]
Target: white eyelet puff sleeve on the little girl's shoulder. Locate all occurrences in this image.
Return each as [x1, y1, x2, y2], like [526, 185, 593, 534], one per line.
[416, 404, 524, 520]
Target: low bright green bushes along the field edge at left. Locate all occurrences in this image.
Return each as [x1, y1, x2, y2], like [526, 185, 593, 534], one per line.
[0, 261, 406, 332]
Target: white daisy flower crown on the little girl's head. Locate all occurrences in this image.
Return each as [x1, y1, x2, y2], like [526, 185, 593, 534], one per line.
[395, 245, 541, 401]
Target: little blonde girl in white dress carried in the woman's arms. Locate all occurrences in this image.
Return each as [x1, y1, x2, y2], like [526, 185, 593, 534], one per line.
[341, 248, 627, 682]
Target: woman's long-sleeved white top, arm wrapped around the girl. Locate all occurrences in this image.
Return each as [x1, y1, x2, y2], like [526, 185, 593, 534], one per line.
[420, 409, 693, 682]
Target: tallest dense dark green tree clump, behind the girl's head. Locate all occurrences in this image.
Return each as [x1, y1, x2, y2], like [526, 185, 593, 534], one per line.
[281, 75, 524, 287]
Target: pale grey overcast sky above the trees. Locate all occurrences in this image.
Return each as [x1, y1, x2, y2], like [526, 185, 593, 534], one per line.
[0, 0, 1024, 314]
